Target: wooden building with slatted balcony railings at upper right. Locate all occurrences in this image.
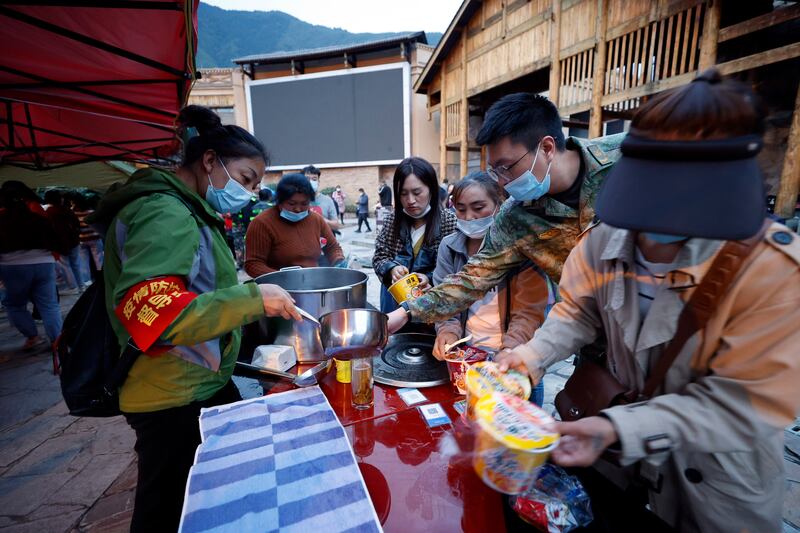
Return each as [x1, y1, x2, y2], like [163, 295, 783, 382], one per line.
[414, 0, 800, 216]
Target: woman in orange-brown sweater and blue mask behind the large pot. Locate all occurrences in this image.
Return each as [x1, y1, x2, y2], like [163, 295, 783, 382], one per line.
[244, 174, 345, 278]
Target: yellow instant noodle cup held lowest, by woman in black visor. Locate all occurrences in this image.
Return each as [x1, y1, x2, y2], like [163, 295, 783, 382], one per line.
[472, 393, 560, 494]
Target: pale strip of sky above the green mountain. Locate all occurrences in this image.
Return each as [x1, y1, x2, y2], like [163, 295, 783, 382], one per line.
[202, 0, 461, 33]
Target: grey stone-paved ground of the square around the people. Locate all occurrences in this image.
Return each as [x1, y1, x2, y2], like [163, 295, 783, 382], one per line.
[0, 211, 800, 533]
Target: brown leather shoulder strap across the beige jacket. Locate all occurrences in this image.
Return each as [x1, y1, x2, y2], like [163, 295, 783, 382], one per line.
[640, 220, 772, 399]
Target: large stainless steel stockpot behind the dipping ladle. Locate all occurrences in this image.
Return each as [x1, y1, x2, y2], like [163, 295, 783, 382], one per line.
[255, 267, 368, 363]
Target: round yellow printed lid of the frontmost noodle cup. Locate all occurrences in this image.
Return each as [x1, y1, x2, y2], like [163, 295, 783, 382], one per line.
[475, 393, 561, 452]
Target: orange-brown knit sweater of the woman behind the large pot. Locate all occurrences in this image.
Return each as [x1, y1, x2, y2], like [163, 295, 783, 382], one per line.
[244, 206, 344, 278]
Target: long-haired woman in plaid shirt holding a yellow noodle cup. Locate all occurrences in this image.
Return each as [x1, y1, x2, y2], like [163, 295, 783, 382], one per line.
[372, 157, 456, 313]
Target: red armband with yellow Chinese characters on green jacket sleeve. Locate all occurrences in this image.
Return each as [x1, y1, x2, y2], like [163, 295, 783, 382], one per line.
[114, 276, 197, 355]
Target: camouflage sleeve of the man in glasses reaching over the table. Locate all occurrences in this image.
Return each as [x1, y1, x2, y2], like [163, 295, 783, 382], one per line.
[408, 205, 525, 324]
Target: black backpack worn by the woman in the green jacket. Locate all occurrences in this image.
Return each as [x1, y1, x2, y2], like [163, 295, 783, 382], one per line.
[53, 271, 141, 416]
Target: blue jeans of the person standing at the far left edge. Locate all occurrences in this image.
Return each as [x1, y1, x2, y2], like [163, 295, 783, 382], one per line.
[0, 263, 62, 342]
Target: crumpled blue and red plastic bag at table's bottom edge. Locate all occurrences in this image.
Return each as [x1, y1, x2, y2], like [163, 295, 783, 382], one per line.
[511, 463, 594, 533]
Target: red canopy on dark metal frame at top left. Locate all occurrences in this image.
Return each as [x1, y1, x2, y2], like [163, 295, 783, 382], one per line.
[0, 0, 199, 168]
